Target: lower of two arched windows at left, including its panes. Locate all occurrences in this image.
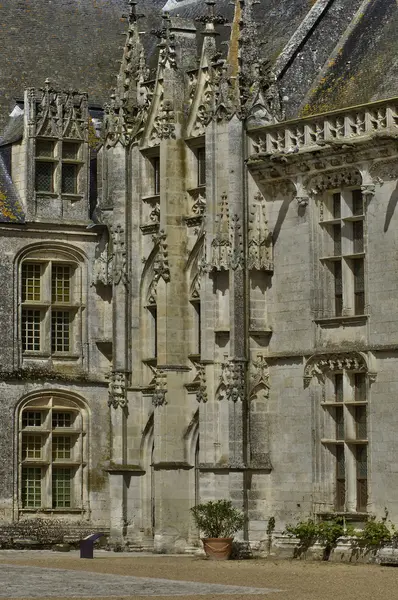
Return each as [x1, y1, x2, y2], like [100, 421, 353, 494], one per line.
[18, 393, 88, 512]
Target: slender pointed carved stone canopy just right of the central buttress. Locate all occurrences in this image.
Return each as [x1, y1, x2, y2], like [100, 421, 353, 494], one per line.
[248, 193, 274, 271]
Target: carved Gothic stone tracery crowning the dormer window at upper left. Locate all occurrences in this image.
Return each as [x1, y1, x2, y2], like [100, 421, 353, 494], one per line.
[32, 79, 89, 141]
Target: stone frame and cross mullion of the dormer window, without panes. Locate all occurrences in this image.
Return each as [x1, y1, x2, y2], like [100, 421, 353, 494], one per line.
[34, 136, 85, 198]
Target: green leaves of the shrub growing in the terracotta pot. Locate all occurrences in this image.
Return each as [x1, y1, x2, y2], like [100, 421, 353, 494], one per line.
[191, 500, 245, 538]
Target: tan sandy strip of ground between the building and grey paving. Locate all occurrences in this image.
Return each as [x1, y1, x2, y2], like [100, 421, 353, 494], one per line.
[0, 551, 398, 600]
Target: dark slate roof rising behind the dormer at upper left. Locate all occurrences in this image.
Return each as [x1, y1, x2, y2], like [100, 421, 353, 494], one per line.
[0, 0, 165, 131]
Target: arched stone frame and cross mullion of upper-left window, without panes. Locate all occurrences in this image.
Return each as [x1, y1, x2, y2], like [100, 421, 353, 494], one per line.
[16, 244, 88, 365]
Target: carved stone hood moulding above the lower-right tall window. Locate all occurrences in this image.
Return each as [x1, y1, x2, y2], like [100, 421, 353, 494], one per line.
[304, 351, 374, 386]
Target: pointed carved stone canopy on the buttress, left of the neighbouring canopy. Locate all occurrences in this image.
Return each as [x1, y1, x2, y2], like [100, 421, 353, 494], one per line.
[209, 194, 244, 271]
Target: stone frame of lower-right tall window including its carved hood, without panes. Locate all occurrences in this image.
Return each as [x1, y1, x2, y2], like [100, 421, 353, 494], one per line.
[304, 351, 376, 515]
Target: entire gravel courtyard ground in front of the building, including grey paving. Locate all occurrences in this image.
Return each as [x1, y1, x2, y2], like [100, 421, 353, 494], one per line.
[0, 550, 398, 600]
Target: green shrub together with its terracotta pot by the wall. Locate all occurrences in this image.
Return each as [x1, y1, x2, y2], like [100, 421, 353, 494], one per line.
[191, 500, 245, 560]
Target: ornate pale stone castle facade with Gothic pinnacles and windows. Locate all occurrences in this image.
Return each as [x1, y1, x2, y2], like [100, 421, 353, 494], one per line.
[0, 0, 398, 552]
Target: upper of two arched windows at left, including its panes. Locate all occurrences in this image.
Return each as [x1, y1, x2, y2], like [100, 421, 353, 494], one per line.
[19, 248, 84, 358]
